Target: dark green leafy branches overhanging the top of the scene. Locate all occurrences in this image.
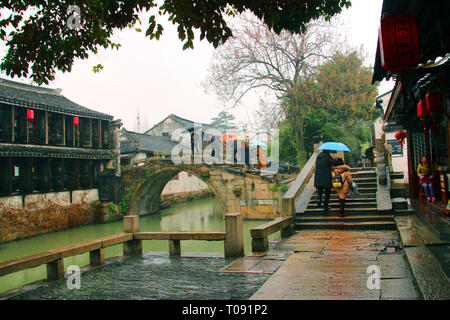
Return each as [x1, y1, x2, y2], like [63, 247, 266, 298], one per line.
[0, 0, 351, 84]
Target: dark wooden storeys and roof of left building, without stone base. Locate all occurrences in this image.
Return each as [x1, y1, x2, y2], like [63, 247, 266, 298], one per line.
[0, 79, 118, 197]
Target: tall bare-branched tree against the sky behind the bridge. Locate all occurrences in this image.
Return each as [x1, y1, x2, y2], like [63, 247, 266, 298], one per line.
[205, 15, 337, 165]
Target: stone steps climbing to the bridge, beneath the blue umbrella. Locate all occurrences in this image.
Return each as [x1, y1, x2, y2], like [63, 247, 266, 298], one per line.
[295, 167, 398, 230]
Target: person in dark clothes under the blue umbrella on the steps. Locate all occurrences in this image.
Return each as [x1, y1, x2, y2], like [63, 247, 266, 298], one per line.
[314, 150, 335, 211]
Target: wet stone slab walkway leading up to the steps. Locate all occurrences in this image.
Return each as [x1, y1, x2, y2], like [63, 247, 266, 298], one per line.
[247, 230, 420, 300]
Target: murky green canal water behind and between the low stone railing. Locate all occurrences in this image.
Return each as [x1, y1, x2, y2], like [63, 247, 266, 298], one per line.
[0, 198, 280, 293]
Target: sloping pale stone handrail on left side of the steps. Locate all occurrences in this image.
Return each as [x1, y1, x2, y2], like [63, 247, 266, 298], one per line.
[281, 151, 320, 216]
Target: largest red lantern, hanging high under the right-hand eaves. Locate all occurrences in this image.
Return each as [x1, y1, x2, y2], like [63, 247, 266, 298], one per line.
[379, 13, 420, 72]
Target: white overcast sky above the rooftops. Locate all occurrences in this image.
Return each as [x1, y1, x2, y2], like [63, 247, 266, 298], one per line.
[2, 0, 393, 132]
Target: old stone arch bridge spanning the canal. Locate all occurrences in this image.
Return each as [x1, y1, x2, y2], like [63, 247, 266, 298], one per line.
[122, 158, 292, 219]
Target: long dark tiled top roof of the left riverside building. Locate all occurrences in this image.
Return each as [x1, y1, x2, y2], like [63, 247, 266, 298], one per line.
[0, 78, 113, 120]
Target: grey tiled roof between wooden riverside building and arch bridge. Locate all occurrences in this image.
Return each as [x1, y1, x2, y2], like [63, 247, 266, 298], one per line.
[120, 130, 178, 154]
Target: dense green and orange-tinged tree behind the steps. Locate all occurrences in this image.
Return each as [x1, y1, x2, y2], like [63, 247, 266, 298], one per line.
[292, 52, 378, 163]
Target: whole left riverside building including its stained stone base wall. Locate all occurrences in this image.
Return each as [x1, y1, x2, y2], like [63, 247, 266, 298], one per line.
[0, 78, 122, 242]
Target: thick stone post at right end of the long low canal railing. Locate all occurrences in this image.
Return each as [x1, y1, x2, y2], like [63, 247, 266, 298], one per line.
[225, 212, 244, 257]
